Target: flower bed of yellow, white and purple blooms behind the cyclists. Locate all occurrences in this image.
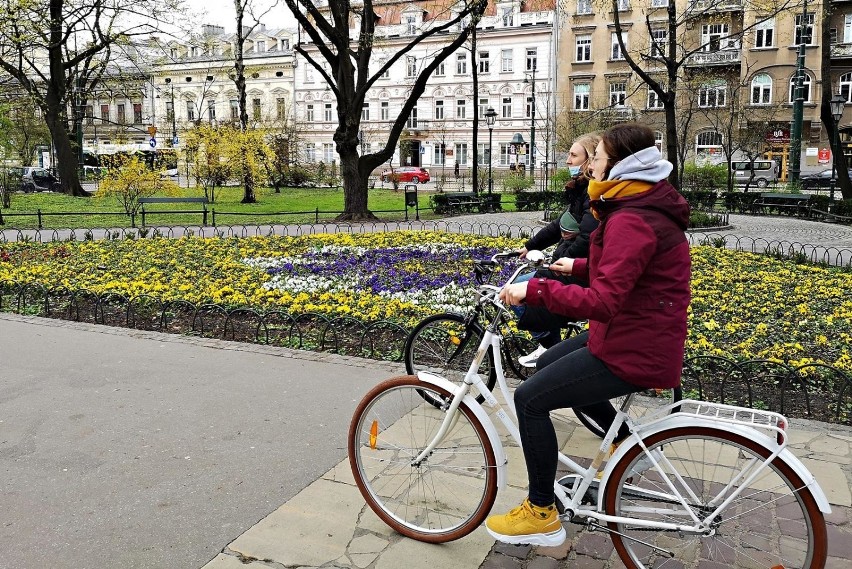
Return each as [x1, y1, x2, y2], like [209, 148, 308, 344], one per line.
[0, 231, 852, 372]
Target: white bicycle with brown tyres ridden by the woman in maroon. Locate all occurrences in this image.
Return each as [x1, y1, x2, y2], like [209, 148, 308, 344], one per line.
[349, 253, 831, 569]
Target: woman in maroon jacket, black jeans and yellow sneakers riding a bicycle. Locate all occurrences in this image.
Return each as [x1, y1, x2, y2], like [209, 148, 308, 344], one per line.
[485, 123, 690, 546]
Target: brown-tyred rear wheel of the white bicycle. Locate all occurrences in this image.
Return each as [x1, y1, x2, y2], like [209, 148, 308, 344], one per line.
[604, 427, 827, 569]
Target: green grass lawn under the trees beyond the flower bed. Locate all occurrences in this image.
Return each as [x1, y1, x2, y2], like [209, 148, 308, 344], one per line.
[0, 187, 515, 229]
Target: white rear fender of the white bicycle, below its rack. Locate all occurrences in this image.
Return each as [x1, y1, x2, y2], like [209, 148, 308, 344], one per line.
[598, 414, 831, 514]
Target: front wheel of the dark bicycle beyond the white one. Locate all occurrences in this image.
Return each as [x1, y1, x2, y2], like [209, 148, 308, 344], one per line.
[405, 312, 497, 406]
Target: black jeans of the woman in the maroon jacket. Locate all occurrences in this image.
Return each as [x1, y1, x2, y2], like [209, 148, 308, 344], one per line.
[515, 332, 643, 506]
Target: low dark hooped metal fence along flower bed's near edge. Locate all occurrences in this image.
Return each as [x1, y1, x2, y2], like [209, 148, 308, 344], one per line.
[0, 281, 852, 425]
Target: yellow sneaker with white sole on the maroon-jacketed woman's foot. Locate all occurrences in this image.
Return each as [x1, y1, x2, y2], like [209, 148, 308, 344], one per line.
[485, 499, 565, 547]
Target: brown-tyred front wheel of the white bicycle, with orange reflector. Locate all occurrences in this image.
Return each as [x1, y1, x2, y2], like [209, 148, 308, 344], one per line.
[349, 376, 497, 543]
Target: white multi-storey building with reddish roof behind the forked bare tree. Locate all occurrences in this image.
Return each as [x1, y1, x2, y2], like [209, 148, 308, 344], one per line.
[295, 0, 555, 171]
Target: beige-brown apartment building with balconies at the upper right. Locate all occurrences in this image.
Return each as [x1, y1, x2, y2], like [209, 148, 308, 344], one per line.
[557, 0, 852, 179]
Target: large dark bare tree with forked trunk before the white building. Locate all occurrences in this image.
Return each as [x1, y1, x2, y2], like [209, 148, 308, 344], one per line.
[285, 0, 488, 220]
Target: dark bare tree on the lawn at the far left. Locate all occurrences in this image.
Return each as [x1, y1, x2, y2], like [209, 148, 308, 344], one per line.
[0, 0, 176, 196]
